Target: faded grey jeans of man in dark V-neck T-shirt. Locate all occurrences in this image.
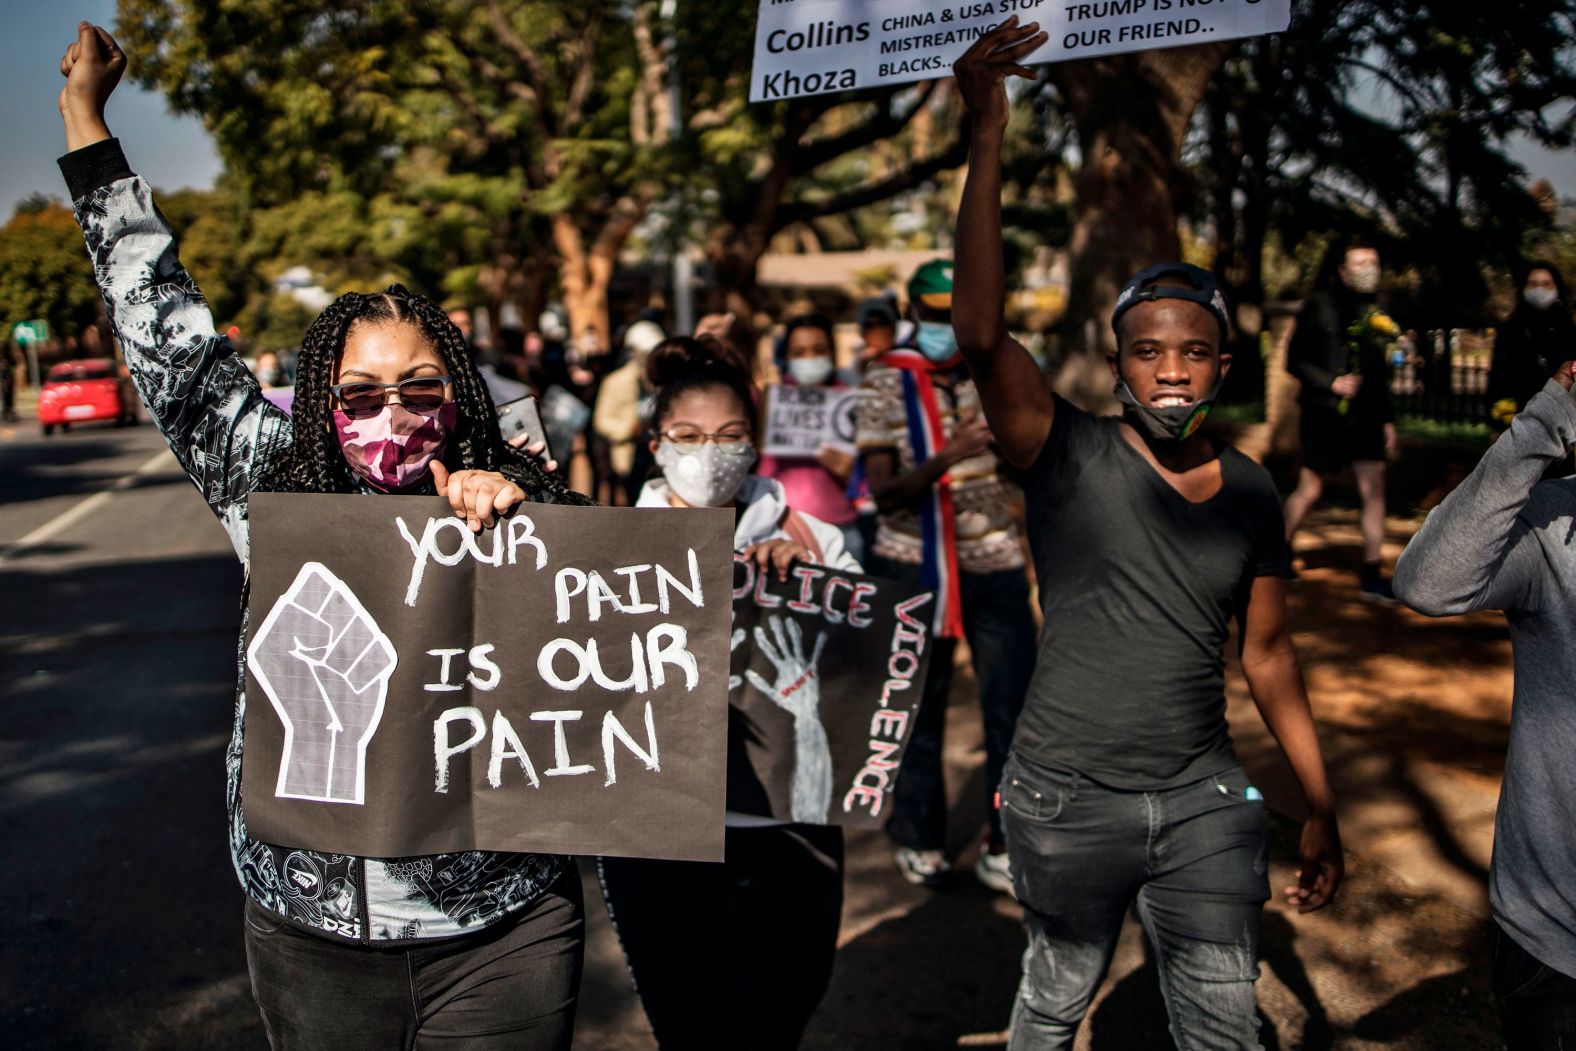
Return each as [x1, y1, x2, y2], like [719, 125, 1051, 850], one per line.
[1001, 755, 1269, 1051]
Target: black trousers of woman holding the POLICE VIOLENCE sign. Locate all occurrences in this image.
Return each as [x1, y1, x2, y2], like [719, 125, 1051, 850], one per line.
[597, 824, 843, 1051]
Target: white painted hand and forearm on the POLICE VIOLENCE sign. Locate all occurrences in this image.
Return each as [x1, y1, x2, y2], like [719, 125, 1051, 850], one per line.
[745, 616, 832, 824]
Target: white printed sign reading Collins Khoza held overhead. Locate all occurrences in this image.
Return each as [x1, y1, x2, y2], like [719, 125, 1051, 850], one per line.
[750, 0, 1291, 102]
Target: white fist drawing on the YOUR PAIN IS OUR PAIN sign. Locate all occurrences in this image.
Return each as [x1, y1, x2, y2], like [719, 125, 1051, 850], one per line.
[246, 563, 397, 805]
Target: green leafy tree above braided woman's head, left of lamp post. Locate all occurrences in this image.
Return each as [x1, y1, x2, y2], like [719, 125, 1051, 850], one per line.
[120, 0, 671, 336]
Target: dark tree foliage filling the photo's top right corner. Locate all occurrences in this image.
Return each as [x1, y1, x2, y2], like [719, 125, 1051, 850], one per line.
[1196, 0, 1576, 326]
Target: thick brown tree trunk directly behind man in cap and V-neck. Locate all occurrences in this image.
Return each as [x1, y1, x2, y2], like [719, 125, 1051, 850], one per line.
[1051, 44, 1231, 407]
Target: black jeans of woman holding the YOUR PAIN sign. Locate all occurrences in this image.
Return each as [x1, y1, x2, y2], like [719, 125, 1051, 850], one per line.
[246, 865, 585, 1051]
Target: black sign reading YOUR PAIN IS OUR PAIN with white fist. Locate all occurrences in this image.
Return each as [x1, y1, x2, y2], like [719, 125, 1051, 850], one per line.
[241, 493, 733, 860]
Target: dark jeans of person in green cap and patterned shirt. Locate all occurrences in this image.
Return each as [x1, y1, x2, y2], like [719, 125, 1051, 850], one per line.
[867, 556, 1034, 851]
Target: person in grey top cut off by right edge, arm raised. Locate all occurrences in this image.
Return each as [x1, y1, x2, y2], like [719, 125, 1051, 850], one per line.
[1395, 359, 1576, 1051]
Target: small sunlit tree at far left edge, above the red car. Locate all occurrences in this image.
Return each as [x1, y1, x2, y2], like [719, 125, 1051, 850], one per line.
[0, 200, 99, 339]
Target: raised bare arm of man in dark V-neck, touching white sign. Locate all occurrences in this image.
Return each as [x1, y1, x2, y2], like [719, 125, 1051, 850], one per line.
[952, 16, 1054, 468]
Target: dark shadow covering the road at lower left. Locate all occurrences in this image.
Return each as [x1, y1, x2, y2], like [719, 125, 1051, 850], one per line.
[0, 556, 265, 1049]
